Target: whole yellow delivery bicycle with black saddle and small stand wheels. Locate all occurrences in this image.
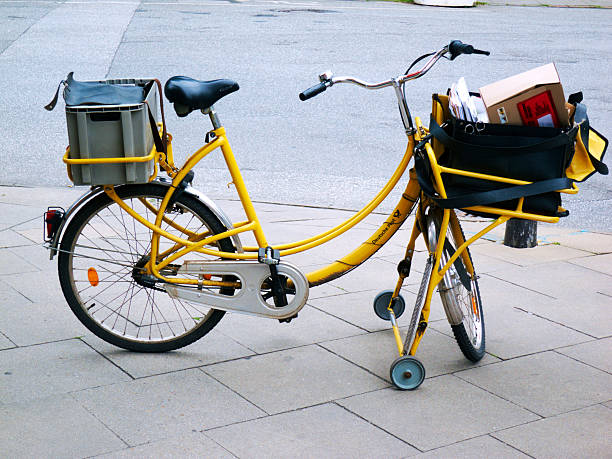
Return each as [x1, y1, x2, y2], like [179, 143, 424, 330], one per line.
[46, 41, 592, 389]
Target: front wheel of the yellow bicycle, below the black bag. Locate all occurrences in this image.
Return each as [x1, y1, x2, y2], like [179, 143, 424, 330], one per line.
[427, 209, 485, 362]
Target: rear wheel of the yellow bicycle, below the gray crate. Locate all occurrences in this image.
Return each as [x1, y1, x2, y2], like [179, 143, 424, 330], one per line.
[58, 183, 236, 352]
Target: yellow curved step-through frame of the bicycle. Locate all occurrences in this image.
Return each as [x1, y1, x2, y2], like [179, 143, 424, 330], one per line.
[104, 120, 420, 286]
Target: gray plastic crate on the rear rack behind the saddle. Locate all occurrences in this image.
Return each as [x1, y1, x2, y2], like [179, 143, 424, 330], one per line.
[66, 79, 159, 185]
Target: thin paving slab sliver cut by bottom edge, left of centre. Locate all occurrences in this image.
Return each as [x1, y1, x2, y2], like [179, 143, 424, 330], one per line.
[96, 432, 236, 459]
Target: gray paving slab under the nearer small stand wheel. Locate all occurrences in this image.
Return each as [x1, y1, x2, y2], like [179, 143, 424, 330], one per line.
[337, 378, 539, 451]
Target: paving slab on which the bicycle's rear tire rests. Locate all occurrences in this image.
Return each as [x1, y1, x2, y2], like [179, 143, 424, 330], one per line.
[83, 329, 253, 378]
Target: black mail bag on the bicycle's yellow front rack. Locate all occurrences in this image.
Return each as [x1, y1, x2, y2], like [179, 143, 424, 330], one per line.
[416, 113, 578, 216]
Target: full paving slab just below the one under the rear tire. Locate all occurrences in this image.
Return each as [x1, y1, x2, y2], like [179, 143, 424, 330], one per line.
[72, 369, 265, 446]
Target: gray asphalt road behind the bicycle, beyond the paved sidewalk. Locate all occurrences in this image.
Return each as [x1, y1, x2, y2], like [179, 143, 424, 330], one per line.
[0, 1, 612, 231]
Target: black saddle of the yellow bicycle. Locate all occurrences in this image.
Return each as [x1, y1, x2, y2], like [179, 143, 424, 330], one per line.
[164, 76, 240, 117]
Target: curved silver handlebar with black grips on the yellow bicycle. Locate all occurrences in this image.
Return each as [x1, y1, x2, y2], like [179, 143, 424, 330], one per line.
[300, 40, 491, 101]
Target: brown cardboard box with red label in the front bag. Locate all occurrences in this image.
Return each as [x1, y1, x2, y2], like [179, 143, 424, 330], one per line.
[480, 64, 569, 127]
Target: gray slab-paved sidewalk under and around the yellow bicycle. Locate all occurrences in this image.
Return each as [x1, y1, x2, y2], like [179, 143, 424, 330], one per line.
[0, 187, 612, 458]
